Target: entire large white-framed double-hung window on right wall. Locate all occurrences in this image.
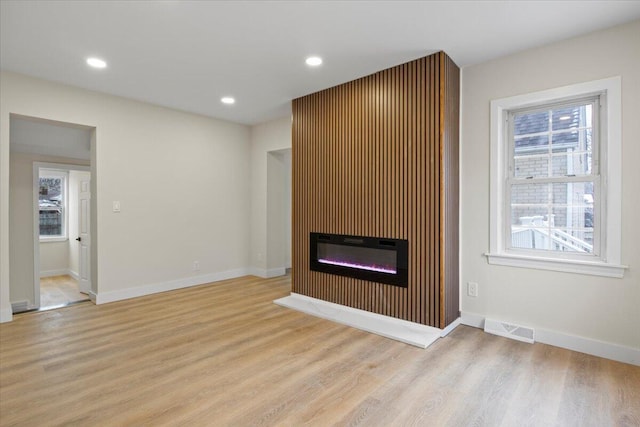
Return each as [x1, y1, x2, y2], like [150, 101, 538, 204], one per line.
[487, 78, 624, 277]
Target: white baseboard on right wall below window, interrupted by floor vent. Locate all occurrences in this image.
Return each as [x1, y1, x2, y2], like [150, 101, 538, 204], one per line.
[461, 312, 640, 366]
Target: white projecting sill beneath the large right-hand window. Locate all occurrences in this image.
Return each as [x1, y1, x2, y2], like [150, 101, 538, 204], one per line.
[485, 253, 629, 279]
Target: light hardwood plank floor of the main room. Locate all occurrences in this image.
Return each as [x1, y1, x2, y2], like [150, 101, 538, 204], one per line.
[0, 277, 640, 427]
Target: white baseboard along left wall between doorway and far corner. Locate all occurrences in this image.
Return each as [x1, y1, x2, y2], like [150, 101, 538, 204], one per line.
[94, 268, 250, 304]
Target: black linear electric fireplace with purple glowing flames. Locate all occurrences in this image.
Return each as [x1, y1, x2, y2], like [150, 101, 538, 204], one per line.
[310, 233, 409, 288]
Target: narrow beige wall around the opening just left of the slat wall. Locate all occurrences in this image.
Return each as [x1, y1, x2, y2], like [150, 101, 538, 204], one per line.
[251, 117, 291, 276]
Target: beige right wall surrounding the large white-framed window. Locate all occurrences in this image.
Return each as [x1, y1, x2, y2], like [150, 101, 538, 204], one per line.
[460, 21, 640, 349]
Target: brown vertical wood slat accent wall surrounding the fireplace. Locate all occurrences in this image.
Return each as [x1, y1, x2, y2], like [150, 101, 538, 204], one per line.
[292, 52, 459, 328]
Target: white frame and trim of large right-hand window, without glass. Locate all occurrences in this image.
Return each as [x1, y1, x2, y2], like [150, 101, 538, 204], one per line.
[486, 77, 627, 278]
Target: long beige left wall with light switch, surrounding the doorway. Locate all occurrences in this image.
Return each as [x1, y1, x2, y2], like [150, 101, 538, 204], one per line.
[0, 72, 250, 320]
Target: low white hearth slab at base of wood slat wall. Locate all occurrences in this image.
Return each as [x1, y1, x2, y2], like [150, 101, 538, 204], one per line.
[274, 292, 443, 348]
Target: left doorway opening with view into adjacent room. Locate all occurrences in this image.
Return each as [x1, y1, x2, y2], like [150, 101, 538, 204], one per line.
[9, 114, 96, 313]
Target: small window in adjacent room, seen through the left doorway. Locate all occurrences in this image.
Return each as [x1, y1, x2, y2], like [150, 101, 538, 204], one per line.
[38, 169, 67, 241]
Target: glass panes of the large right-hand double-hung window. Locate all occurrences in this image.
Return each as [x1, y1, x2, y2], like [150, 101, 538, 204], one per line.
[508, 98, 599, 254]
